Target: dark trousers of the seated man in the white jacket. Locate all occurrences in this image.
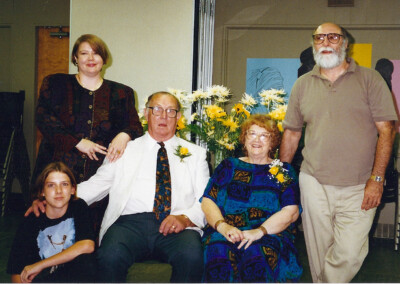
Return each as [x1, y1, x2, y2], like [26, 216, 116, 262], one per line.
[97, 213, 203, 282]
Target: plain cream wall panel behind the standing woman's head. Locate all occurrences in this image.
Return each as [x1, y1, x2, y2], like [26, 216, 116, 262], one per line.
[70, 0, 194, 112]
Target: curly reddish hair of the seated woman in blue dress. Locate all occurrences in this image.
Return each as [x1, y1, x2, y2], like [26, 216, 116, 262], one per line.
[239, 114, 282, 158]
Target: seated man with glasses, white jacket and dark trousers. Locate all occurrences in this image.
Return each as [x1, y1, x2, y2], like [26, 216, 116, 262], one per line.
[30, 92, 209, 282]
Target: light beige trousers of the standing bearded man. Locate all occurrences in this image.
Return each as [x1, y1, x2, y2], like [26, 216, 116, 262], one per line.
[299, 172, 376, 283]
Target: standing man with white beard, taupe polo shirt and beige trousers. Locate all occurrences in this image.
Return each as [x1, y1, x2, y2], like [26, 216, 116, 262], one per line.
[280, 23, 397, 282]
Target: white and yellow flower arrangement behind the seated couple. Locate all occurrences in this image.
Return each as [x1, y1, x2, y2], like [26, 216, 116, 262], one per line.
[139, 85, 287, 165]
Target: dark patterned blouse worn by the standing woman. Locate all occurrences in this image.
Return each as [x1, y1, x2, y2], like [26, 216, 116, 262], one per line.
[32, 74, 143, 183]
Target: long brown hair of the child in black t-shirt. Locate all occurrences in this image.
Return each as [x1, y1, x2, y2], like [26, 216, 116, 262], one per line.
[33, 162, 77, 200]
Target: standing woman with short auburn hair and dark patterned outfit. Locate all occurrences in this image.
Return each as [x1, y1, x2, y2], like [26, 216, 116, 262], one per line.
[31, 34, 143, 233]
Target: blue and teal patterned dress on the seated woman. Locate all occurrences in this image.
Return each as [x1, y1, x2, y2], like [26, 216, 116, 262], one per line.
[203, 158, 303, 282]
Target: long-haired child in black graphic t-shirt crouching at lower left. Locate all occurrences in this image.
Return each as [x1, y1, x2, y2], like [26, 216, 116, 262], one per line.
[7, 162, 96, 282]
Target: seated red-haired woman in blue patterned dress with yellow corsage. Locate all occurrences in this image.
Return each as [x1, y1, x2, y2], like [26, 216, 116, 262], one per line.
[201, 114, 303, 282]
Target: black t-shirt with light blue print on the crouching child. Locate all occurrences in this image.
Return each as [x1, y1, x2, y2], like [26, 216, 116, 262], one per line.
[7, 199, 95, 274]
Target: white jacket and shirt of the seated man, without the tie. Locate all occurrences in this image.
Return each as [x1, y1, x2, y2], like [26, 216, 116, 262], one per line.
[77, 133, 209, 241]
